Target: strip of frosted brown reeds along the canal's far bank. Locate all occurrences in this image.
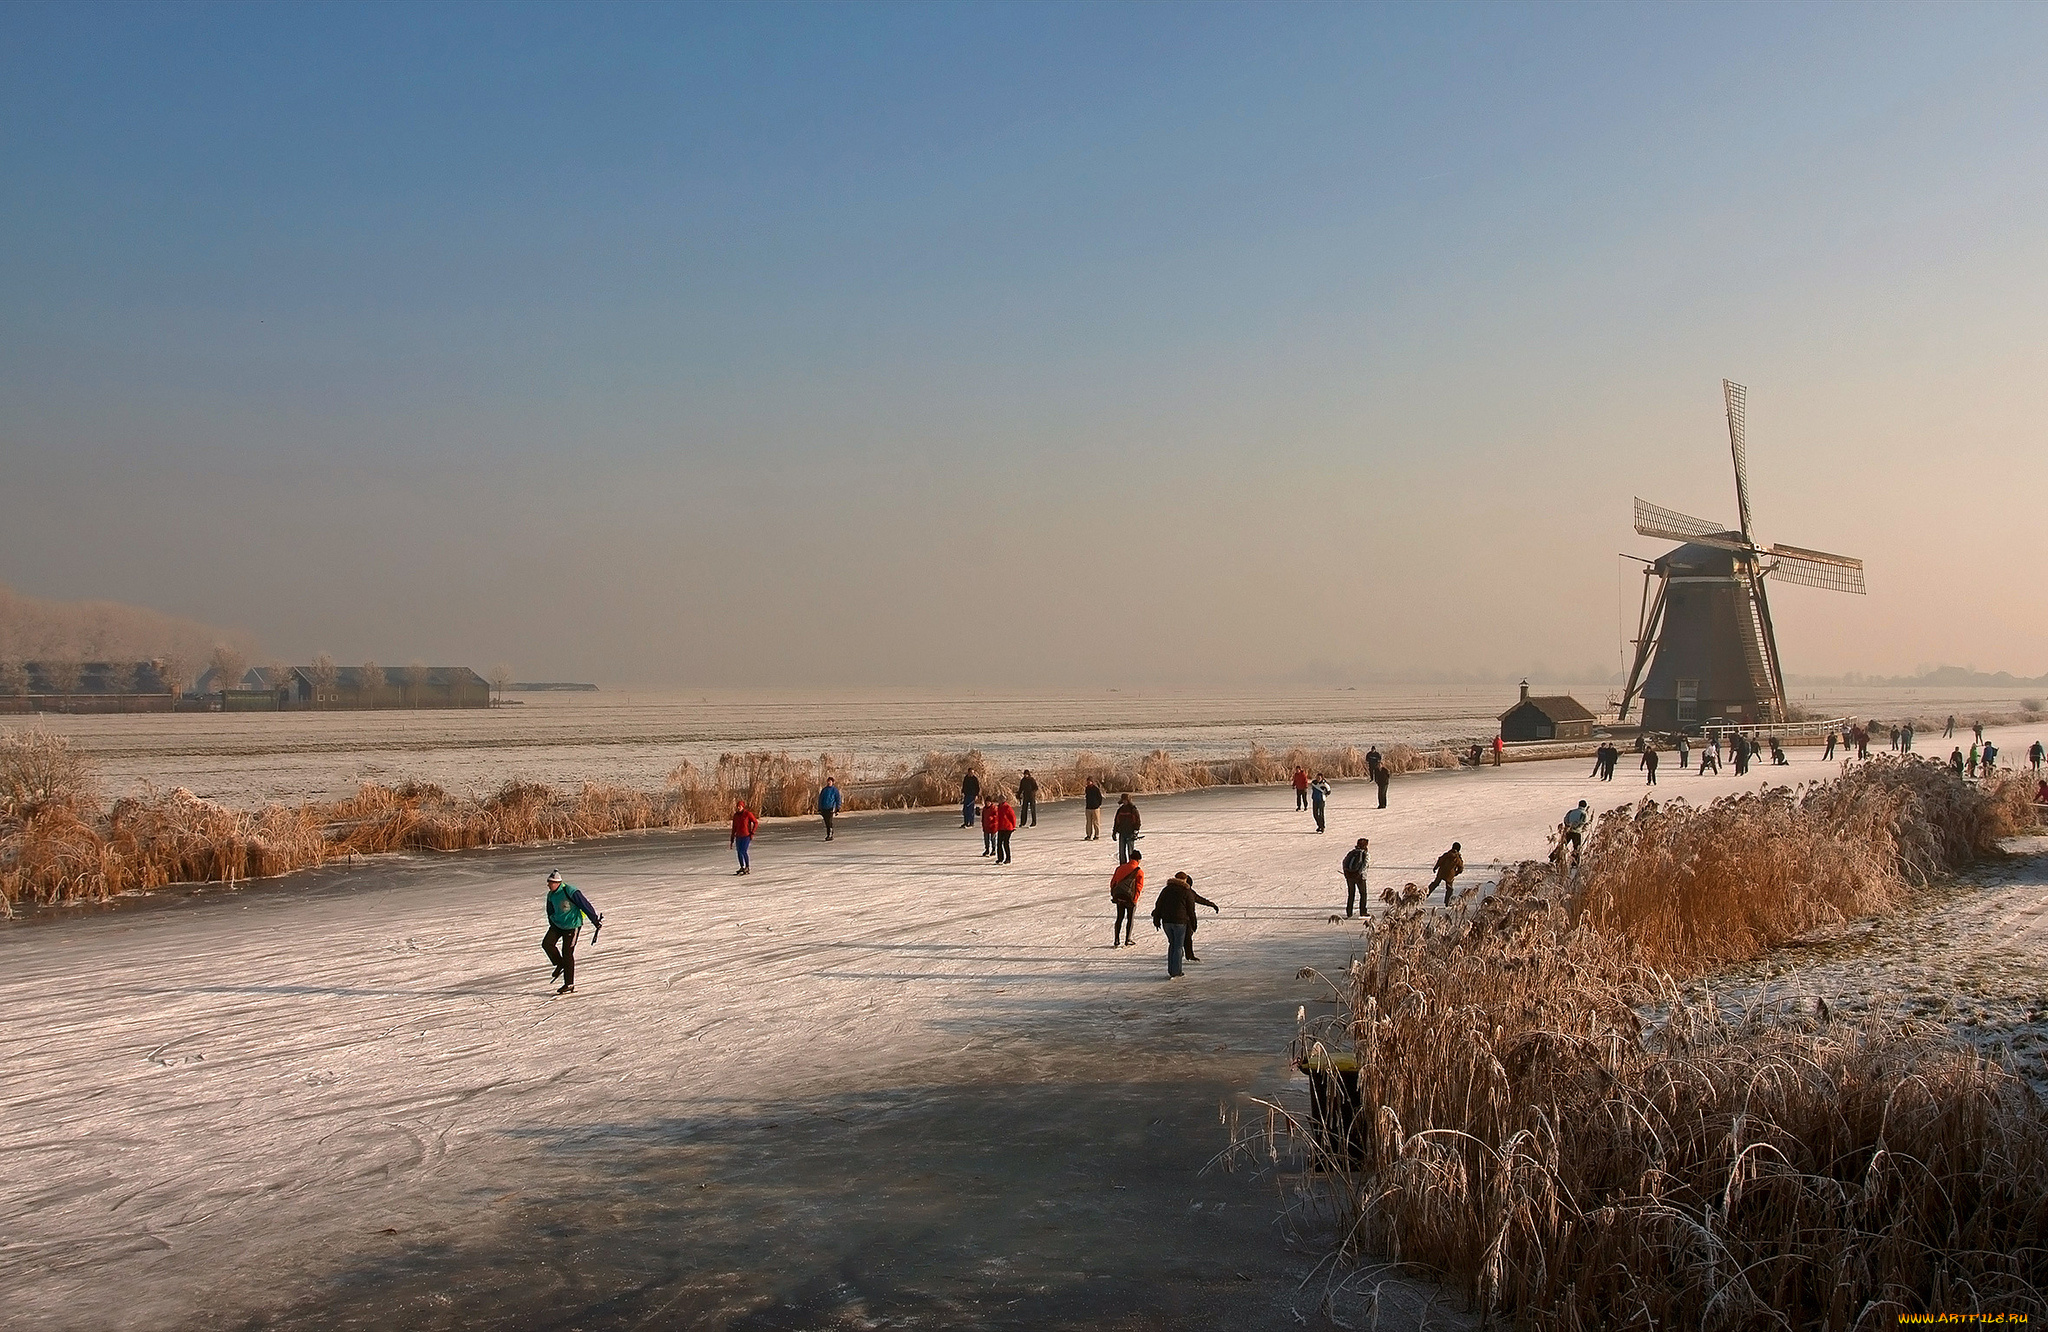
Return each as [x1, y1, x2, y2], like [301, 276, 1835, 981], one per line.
[0, 732, 1456, 912]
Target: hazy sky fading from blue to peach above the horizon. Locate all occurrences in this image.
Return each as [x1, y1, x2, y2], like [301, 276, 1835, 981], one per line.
[0, 4, 2048, 686]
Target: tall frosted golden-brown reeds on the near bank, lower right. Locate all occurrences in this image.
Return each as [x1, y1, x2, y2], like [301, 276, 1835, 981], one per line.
[1298, 758, 2048, 1328]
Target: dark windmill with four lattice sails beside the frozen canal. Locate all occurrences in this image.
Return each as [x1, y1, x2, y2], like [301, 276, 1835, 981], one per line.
[1620, 379, 1864, 732]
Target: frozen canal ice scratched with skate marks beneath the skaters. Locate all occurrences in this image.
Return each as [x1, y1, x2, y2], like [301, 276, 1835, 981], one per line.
[0, 732, 2042, 1328]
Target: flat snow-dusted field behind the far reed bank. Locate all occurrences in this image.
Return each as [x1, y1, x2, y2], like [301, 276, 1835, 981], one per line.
[16, 682, 2017, 805]
